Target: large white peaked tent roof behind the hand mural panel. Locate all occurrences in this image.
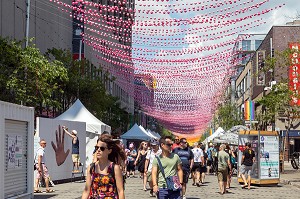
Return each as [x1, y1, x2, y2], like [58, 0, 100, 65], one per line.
[56, 99, 111, 134]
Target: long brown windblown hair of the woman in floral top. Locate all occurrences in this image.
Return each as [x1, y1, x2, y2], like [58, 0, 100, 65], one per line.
[97, 136, 126, 165]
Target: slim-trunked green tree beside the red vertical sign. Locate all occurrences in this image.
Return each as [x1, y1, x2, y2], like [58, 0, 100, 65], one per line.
[258, 49, 300, 170]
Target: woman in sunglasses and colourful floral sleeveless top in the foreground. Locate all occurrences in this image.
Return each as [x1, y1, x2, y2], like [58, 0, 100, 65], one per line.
[82, 138, 126, 199]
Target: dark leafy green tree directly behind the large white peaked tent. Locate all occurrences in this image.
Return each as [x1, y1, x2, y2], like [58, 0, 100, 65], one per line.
[46, 48, 129, 136]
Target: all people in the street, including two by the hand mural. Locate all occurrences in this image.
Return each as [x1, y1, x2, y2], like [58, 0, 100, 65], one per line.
[35, 131, 255, 199]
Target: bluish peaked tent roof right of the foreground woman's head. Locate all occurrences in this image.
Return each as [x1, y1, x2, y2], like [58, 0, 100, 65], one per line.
[121, 124, 153, 141]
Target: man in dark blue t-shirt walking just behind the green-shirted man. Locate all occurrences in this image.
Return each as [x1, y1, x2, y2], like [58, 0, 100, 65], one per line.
[173, 138, 194, 199]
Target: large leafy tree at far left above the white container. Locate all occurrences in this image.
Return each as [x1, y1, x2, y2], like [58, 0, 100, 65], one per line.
[0, 38, 68, 115]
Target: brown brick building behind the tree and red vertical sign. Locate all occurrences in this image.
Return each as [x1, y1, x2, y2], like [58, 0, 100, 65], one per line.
[236, 25, 300, 159]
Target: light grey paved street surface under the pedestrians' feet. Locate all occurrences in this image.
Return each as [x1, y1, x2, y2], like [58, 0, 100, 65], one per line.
[34, 175, 300, 199]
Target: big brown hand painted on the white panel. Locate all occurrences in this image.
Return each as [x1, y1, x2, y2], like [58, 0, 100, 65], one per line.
[51, 125, 70, 166]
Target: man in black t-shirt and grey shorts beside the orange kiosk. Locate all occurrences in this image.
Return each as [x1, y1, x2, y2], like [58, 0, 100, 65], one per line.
[240, 142, 255, 189]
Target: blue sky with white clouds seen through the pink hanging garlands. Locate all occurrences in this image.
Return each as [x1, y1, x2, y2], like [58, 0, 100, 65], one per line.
[132, 0, 300, 134]
